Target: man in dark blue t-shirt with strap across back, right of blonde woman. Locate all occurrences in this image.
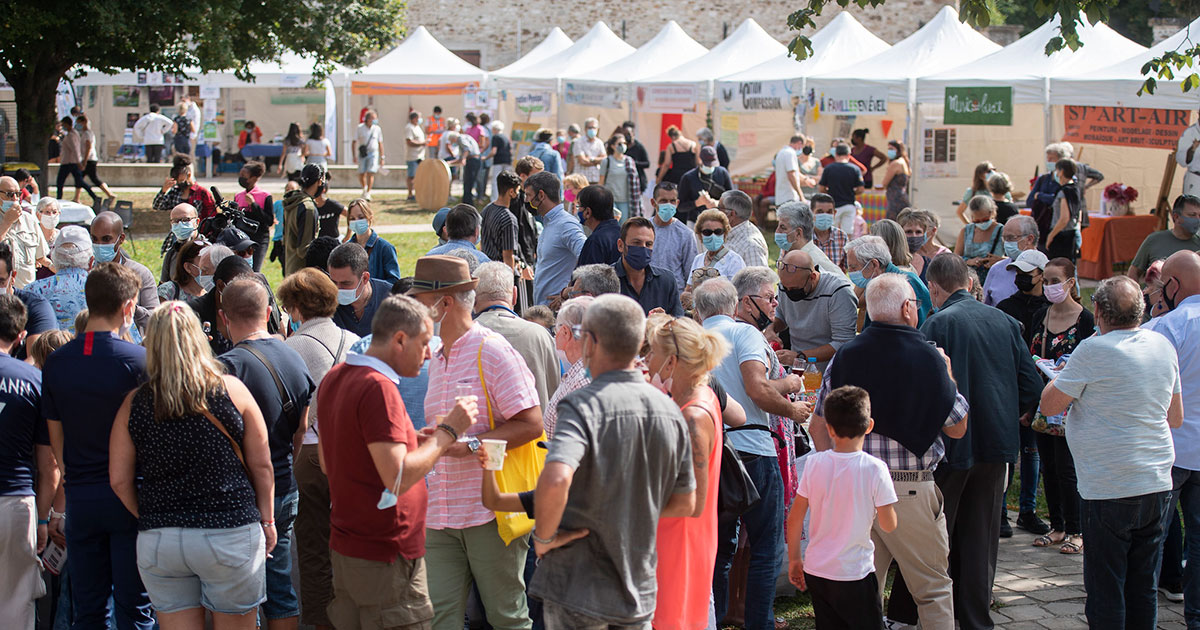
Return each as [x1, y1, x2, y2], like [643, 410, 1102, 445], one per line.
[218, 276, 317, 628]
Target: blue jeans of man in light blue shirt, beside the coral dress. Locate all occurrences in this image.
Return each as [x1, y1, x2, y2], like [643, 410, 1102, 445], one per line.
[710, 452, 784, 630]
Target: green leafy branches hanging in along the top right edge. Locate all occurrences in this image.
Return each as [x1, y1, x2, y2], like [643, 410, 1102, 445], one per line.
[787, 0, 1200, 95]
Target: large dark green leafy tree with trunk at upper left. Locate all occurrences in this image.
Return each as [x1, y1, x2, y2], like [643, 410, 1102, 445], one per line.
[0, 0, 404, 173]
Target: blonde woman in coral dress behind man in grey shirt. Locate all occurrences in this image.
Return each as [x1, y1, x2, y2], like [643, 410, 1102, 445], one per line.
[646, 316, 730, 630]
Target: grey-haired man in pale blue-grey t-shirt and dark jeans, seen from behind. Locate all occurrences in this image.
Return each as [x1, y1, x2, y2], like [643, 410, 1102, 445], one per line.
[1042, 276, 1183, 628]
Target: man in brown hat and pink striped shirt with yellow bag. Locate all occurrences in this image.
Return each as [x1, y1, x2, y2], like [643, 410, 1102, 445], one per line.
[408, 256, 542, 630]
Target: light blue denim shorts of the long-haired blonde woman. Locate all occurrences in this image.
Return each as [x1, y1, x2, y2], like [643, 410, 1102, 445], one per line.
[138, 523, 266, 614]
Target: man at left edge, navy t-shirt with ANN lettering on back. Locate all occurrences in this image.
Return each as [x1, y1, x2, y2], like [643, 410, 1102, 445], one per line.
[0, 292, 59, 628]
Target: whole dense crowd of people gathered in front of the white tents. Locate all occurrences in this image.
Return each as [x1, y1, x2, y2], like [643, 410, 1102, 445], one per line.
[0, 100, 1200, 630]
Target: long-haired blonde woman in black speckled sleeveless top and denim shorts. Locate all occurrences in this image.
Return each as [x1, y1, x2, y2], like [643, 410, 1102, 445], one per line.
[108, 301, 276, 630]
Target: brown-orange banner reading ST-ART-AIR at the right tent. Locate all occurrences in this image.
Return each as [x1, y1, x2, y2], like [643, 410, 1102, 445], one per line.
[1062, 106, 1190, 150]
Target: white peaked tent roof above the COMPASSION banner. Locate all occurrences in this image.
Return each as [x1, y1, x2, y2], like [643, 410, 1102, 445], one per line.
[719, 11, 892, 83]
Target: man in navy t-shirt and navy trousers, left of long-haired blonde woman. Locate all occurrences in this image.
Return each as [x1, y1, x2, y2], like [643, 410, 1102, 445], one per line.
[42, 263, 154, 630]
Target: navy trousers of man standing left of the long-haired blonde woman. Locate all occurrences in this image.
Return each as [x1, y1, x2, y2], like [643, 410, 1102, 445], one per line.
[66, 486, 154, 630]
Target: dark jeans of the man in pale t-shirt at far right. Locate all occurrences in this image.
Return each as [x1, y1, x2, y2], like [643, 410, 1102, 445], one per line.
[1084, 491, 1166, 630]
